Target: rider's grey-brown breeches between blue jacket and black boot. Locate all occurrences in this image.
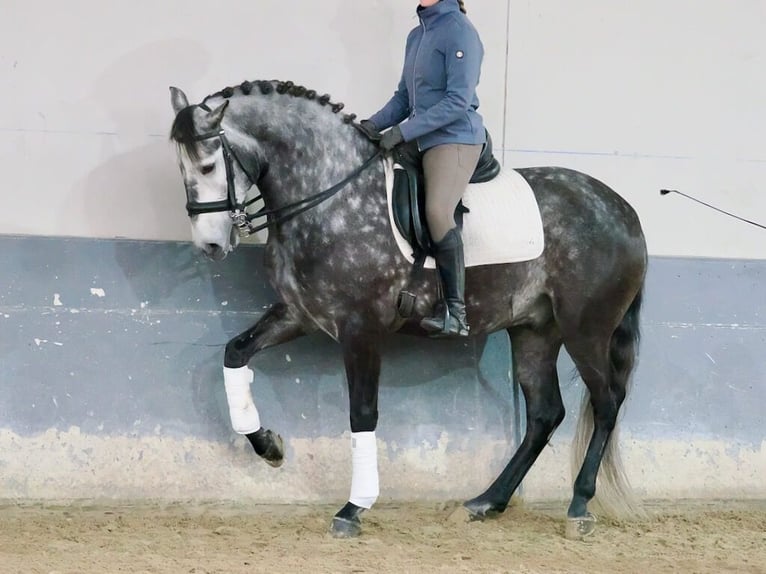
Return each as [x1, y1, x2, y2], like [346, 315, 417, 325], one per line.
[423, 144, 482, 243]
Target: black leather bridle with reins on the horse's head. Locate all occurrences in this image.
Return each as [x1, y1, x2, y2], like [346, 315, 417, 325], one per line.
[181, 103, 382, 237]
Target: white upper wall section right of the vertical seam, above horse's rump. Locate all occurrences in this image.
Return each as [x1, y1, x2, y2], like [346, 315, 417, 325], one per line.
[505, 0, 766, 258]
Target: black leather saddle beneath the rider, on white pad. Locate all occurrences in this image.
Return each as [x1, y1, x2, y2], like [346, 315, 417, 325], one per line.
[391, 132, 500, 260]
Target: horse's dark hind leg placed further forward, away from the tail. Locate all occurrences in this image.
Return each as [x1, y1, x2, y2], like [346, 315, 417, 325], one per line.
[465, 325, 565, 519]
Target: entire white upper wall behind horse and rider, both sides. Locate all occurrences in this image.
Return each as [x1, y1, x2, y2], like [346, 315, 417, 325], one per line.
[0, 0, 766, 258]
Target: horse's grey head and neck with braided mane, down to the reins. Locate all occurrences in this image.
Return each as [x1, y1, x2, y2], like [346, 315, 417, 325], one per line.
[170, 80, 385, 259]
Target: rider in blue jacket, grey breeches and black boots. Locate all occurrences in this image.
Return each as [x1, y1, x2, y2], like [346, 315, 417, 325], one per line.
[360, 0, 486, 336]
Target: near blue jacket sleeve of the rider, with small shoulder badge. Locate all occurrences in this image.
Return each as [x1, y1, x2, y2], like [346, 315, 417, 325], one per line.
[399, 26, 484, 141]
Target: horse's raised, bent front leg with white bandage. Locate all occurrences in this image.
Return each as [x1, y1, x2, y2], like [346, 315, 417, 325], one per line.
[223, 303, 306, 466]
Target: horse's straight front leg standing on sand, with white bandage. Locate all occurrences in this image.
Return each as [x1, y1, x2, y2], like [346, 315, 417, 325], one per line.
[331, 330, 388, 538]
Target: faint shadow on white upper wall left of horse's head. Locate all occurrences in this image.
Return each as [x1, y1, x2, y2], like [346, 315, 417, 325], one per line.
[62, 38, 211, 242]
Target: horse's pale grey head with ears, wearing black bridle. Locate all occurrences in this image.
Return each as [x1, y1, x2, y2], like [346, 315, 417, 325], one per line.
[170, 88, 252, 260]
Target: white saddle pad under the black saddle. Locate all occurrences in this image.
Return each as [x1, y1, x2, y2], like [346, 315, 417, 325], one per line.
[385, 159, 545, 269]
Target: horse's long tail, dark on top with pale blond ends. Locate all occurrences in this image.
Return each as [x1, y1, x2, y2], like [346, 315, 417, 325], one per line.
[572, 289, 645, 519]
